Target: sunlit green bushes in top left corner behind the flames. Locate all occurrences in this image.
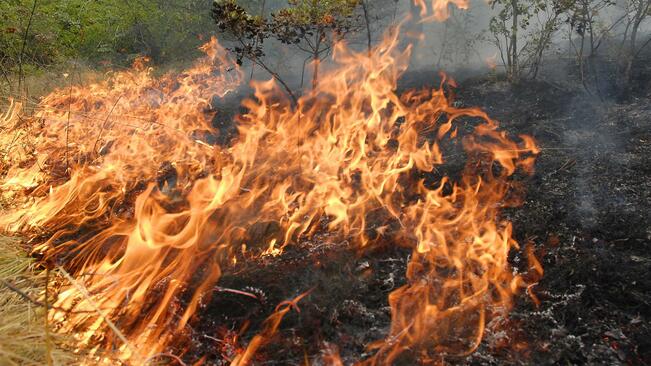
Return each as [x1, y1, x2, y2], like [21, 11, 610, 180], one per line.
[0, 0, 212, 74]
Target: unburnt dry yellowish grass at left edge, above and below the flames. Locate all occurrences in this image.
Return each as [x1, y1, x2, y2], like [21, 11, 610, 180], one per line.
[0, 64, 129, 366]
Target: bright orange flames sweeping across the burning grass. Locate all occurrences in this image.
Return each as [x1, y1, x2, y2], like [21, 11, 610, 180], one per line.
[0, 2, 539, 364]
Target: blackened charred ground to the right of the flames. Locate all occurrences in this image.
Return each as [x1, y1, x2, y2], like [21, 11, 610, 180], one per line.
[462, 78, 651, 365]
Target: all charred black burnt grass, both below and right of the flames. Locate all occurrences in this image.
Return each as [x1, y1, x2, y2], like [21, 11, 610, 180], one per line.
[171, 73, 651, 365]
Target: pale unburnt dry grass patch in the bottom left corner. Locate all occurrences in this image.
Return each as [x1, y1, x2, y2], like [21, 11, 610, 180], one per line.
[0, 237, 79, 365]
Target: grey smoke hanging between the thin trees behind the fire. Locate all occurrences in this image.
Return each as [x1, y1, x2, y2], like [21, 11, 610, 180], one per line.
[211, 0, 651, 106]
